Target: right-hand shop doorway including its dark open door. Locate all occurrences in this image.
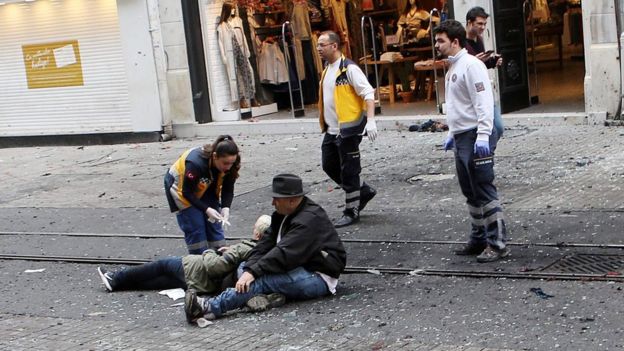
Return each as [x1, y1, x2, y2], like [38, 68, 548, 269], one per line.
[494, 0, 585, 113]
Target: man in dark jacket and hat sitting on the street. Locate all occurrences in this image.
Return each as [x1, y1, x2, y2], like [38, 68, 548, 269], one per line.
[184, 174, 347, 322]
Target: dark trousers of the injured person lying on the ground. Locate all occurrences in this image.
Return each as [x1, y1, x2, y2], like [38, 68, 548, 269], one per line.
[113, 257, 186, 290]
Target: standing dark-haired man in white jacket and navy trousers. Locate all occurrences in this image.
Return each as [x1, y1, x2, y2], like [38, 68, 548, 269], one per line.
[434, 20, 510, 262]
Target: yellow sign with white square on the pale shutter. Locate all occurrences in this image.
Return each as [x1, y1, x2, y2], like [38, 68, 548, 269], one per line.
[22, 40, 84, 89]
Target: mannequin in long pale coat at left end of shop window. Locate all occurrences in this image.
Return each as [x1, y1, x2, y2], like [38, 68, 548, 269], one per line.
[217, 3, 256, 108]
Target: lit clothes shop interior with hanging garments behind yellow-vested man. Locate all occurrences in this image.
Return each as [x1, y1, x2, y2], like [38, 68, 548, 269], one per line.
[224, 0, 446, 119]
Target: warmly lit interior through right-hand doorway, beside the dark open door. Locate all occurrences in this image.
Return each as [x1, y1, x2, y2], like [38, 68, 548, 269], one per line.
[516, 0, 585, 113]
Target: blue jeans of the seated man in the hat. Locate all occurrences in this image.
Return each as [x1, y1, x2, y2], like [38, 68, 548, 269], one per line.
[208, 267, 329, 317]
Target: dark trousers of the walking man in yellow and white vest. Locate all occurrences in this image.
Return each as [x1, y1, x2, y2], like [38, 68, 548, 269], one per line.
[321, 133, 362, 211]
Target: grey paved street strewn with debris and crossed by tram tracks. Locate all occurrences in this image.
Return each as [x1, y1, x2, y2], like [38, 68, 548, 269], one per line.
[0, 125, 624, 351]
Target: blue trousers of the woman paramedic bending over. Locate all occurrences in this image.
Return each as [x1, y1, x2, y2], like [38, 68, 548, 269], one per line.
[176, 206, 225, 255]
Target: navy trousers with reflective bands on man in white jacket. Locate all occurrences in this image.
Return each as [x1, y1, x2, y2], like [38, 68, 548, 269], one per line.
[453, 128, 507, 250]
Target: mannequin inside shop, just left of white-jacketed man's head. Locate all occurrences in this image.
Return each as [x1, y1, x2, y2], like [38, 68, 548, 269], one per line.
[396, 0, 440, 44]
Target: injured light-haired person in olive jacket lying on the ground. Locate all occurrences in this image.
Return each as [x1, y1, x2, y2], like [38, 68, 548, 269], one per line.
[98, 215, 271, 294]
